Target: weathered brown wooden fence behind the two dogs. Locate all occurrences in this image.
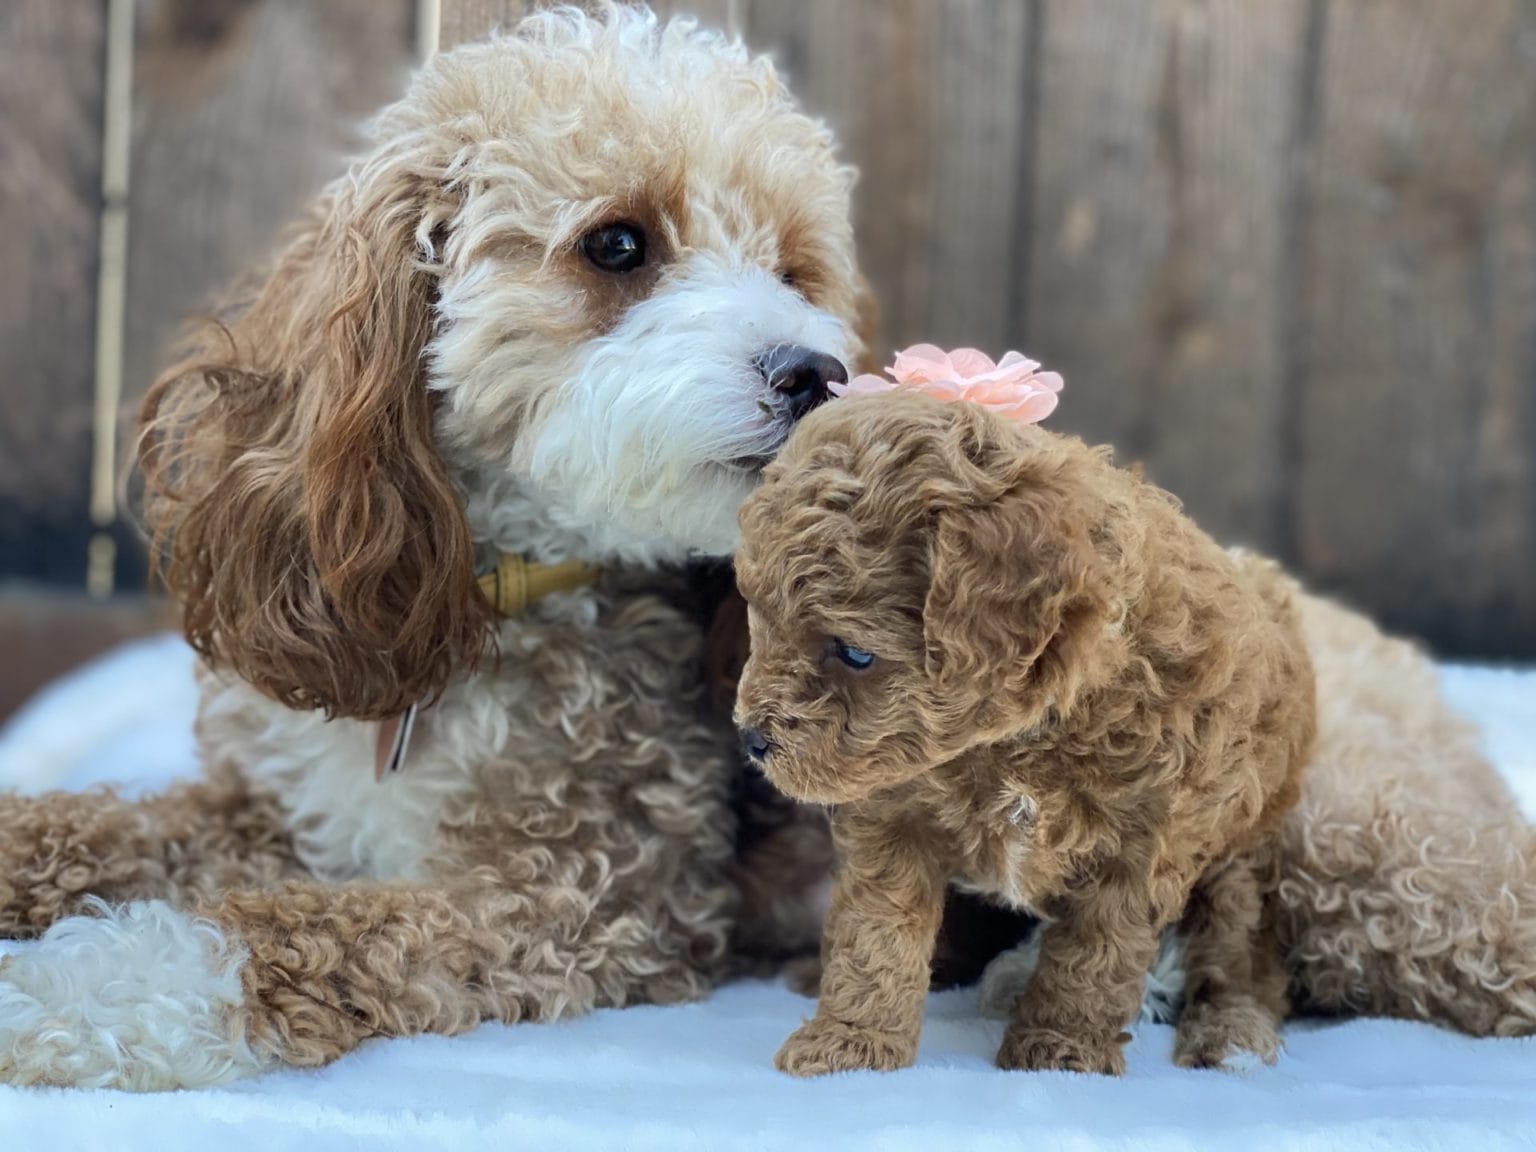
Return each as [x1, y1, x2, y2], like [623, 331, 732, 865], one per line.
[0, 0, 1536, 659]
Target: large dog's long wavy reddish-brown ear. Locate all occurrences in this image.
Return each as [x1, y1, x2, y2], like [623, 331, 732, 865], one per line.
[140, 158, 490, 719]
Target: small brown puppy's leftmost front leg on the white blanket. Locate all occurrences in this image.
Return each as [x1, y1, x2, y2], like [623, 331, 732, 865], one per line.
[774, 817, 946, 1077]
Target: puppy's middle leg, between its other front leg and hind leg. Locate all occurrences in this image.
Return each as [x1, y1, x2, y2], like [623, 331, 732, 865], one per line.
[997, 880, 1166, 1075]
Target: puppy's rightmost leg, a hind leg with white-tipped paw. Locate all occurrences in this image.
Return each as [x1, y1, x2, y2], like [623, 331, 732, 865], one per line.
[1174, 857, 1286, 1068]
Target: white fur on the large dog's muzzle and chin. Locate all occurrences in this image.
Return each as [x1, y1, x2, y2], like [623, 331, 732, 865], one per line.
[510, 253, 851, 558]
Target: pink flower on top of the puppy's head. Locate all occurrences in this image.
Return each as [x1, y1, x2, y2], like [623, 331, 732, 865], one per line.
[831, 344, 1061, 424]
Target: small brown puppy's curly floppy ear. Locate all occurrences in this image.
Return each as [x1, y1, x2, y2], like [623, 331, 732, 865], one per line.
[923, 413, 1111, 710]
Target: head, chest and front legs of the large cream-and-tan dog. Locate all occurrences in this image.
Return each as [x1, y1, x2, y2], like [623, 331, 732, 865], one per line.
[0, 8, 860, 1089]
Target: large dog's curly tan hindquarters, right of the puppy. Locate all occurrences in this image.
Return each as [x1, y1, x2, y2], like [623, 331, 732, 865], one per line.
[1276, 598, 1536, 1035]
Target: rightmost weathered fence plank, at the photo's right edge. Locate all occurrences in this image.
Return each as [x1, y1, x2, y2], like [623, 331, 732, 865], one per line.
[1298, 0, 1536, 657]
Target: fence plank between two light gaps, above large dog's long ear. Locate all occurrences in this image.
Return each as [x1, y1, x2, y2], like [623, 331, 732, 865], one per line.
[124, 0, 416, 568]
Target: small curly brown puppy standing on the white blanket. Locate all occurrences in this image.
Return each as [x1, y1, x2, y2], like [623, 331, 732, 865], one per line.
[737, 393, 1315, 1075]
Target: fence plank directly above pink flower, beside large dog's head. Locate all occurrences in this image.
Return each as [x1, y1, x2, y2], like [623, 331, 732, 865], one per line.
[748, 0, 1034, 362]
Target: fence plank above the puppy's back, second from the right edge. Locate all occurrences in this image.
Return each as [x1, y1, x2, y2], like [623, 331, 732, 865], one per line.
[1017, 0, 1307, 554]
